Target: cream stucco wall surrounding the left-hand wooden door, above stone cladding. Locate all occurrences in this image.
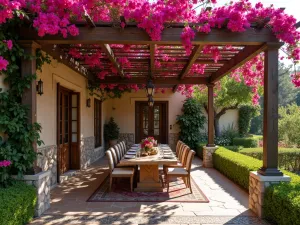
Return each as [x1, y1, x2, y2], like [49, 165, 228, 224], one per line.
[37, 57, 106, 146]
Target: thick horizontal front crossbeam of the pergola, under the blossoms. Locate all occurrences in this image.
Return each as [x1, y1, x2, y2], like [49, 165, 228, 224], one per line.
[19, 25, 278, 45]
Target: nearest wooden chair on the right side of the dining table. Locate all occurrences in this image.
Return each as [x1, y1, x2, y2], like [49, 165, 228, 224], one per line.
[166, 150, 195, 193]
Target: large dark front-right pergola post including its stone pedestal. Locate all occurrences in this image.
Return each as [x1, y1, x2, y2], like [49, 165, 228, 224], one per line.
[249, 43, 290, 218]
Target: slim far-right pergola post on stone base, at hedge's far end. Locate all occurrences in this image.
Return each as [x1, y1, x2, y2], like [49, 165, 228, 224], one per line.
[203, 83, 217, 167]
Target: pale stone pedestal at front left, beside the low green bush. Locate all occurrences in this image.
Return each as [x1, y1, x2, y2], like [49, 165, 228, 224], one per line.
[23, 170, 51, 217]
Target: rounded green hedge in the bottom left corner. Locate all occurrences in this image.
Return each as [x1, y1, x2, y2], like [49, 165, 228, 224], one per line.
[0, 181, 36, 225]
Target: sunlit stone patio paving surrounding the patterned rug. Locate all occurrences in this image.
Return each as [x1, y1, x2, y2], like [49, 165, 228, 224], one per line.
[31, 158, 268, 225]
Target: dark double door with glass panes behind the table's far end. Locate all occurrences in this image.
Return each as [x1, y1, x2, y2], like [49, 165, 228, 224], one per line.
[135, 102, 168, 143]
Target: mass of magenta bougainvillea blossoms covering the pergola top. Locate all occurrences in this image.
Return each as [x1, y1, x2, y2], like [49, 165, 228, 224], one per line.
[0, 0, 300, 100]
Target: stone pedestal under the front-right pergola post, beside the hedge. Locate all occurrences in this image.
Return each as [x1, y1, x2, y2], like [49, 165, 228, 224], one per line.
[249, 171, 291, 218]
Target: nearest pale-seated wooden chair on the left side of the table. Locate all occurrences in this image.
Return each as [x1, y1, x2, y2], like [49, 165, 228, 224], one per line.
[106, 150, 134, 191]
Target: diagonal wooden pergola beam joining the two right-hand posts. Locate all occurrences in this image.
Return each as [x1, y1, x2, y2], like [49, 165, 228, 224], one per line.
[210, 44, 267, 83]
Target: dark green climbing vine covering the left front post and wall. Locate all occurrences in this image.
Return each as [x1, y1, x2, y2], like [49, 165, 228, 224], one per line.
[0, 18, 50, 186]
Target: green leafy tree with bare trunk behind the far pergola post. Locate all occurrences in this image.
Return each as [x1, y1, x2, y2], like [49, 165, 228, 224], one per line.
[194, 76, 253, 137]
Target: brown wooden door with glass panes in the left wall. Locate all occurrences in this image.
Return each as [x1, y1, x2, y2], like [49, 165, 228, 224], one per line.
[57, 84, 80, 181]
